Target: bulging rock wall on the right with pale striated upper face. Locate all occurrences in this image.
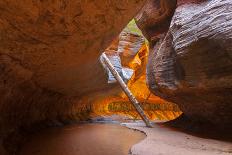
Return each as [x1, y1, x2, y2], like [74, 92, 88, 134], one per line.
[140, 0, 232, 127]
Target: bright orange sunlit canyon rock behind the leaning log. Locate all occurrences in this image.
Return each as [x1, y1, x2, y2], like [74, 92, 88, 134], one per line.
[73, 28, 182, 120]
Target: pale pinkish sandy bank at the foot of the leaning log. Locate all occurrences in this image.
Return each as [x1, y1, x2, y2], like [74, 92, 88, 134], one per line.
[122, 122, 232, 155]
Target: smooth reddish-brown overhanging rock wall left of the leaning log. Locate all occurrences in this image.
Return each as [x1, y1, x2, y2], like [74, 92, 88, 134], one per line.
[0, 0, 145, 153]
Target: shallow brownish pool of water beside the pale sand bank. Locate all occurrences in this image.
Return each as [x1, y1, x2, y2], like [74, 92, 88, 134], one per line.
[19, 123, 145, 155]
